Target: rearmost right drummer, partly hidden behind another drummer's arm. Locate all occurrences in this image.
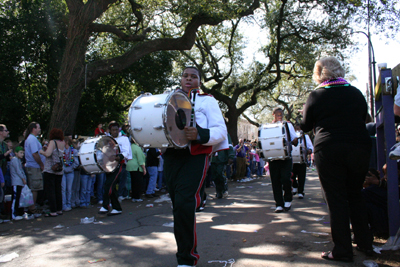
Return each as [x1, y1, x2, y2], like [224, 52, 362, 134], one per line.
[292, 123, 314, 199]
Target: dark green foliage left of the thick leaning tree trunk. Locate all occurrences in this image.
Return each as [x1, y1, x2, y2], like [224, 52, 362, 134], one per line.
[0, 0, 66, 140]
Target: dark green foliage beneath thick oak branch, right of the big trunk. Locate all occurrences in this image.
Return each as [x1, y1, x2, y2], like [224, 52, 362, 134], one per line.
[75, 52, 173, 135]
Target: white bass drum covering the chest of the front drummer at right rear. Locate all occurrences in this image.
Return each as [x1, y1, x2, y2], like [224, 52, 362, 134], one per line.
[258, 122, 291, 161]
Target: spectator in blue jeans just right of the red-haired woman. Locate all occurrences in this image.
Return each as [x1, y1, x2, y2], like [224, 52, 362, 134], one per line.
[61, 135, 79, 211]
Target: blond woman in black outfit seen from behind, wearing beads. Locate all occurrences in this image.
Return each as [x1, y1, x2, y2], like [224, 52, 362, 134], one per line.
[301, 57, 372, 261]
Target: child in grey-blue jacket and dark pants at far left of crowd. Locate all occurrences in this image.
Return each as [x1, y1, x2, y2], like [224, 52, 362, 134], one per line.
[10, 146, 34, 221]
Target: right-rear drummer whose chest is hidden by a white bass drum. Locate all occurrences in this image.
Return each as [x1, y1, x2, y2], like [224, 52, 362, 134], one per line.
[269, 107, 298, 213]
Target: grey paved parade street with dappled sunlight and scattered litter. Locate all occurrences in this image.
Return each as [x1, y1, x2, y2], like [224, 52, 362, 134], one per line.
[0, 170, 396, 267]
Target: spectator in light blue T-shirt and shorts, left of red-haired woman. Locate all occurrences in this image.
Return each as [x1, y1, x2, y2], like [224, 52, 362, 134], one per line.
[24, 122, 45, 216]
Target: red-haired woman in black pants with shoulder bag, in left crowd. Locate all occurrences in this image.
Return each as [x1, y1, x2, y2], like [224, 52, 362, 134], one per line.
[39, 128, 65, 217]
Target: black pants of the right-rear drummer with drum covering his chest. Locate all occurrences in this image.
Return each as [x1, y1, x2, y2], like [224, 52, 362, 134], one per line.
[269, 159, 293, 207]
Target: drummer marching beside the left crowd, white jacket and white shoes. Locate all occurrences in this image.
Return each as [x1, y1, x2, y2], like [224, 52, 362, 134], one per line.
[99, 121, 132, 216]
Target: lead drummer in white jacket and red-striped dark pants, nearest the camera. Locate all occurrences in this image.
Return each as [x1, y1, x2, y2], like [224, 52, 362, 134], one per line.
[164, 67, 229, 267]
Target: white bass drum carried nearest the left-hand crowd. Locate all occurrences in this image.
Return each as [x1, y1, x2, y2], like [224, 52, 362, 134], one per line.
[78, 136, 120, 174]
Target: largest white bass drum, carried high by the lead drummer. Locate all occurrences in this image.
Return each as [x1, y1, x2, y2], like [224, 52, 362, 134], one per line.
[129, 91, 192, 148]
